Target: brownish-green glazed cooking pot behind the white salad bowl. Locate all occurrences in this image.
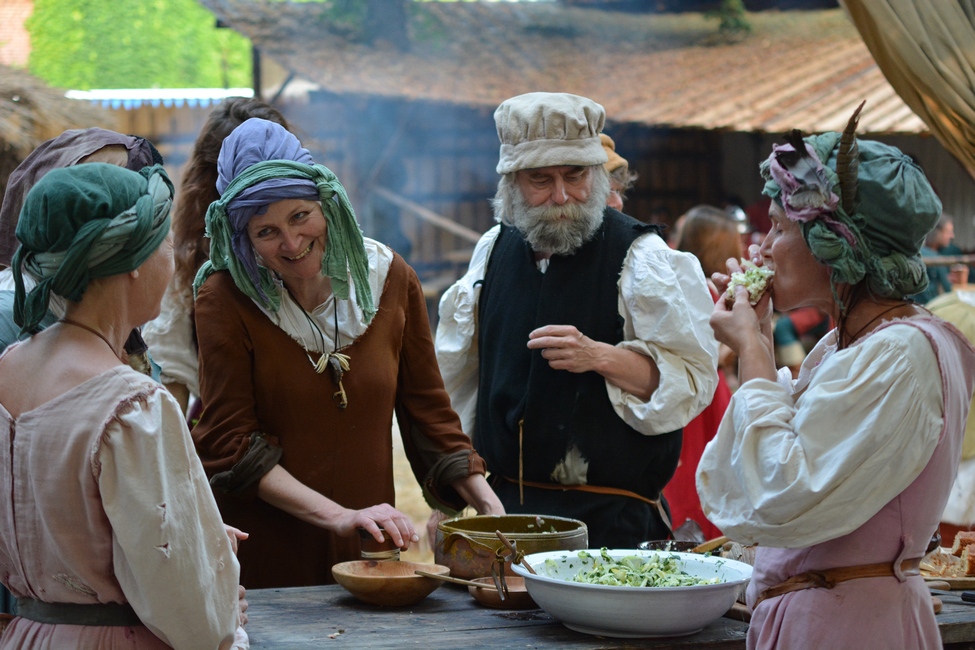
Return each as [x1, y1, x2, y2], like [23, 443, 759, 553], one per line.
[433, 515, 589, 580]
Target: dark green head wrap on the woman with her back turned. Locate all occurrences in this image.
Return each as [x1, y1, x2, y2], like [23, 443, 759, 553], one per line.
[11, 163, 173, 333]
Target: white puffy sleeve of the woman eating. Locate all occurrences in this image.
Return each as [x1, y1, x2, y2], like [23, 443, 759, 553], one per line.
[697, 323, 943, 548]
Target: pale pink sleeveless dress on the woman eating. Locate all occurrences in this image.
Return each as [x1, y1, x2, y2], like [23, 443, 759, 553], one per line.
[747, 318, 975, 650]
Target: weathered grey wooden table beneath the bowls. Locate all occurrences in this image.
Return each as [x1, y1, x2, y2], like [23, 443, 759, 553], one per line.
[247, 585, 975, 650]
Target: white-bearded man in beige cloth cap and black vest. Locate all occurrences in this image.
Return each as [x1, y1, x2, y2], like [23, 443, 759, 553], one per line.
[436, 93, 718, 548]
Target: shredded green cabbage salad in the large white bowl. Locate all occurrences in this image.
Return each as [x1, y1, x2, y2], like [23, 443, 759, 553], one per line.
[545, 548, 724, 587]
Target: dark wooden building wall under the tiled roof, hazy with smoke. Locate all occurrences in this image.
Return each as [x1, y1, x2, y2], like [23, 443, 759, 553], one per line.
[101, 92, 975, 326]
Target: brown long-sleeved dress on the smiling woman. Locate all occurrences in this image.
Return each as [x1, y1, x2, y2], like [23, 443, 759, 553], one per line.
[193, 255, 484, 589]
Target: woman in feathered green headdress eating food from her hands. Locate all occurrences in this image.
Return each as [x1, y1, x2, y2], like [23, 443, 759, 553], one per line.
[697, 107, 975, 650]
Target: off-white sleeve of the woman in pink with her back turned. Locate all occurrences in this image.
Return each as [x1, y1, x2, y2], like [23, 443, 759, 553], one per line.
[97, 391, 249, 648]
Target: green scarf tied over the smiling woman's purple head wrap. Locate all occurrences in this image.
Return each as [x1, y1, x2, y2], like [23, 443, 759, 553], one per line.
[193, 158, 376, 322]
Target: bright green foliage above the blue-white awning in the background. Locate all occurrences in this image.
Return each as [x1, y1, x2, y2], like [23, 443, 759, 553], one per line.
[27, 0, 251, 90]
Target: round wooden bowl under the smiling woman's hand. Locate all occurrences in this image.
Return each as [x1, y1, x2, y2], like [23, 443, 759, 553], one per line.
[332, 560, 450, 607]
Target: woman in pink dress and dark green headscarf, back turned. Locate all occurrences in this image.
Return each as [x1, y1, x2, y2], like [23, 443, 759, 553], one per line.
[0, 163, 246, 648]
